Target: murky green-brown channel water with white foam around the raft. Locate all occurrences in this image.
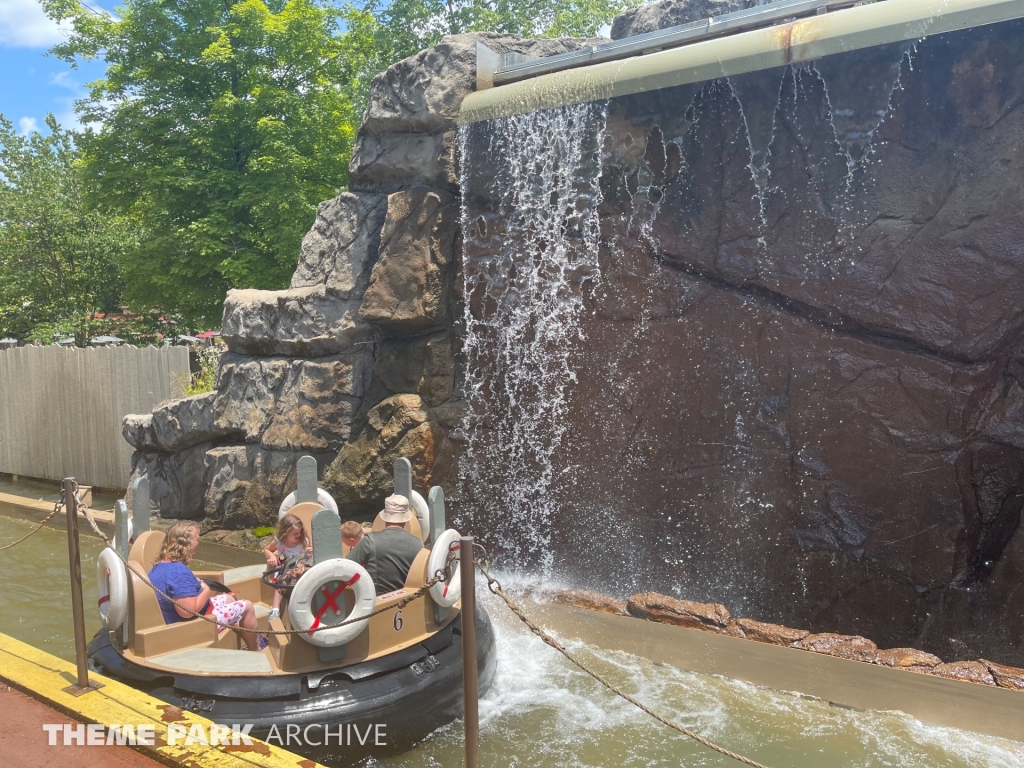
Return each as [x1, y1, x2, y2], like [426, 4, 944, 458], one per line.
[0, 517, 1024, 768]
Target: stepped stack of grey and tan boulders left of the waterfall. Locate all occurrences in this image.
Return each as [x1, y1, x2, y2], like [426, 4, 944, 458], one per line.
[123, 34, 594, 527]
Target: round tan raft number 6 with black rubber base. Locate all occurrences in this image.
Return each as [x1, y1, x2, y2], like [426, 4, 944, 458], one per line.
[89, 457, 496, 765]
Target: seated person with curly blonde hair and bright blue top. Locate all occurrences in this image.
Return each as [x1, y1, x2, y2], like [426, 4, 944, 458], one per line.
[150, 521, 267, 650]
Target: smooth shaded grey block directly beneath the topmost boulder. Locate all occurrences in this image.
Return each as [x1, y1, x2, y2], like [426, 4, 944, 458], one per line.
[348, 131, 459, 193]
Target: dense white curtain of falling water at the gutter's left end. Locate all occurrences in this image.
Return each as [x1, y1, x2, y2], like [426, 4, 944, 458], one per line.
[460, 103, 606, 569]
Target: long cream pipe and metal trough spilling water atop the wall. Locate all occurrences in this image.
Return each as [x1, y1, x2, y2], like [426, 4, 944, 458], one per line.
[459, 0, 1024, 125]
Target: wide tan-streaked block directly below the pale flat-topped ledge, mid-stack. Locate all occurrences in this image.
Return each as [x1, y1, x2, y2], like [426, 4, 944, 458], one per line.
[216, 351, 372, 452]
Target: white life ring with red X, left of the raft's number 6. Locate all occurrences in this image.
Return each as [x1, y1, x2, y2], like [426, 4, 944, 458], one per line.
[288, 558, 377, 648]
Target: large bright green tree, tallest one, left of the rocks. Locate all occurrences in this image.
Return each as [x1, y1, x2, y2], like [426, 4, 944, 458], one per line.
[43, 0, 357, 325]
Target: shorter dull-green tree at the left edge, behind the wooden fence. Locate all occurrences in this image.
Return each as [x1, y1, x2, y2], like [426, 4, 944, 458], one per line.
[0, 115, 136, 343]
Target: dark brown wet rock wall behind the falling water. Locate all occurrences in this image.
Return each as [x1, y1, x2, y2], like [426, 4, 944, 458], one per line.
[463, 8, 1024, 666]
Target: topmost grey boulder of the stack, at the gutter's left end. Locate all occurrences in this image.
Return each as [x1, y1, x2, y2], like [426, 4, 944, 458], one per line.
[360, 32, 602, 135]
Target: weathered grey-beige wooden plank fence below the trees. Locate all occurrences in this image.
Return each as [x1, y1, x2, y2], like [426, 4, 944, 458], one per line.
[0, 346, 188, 488]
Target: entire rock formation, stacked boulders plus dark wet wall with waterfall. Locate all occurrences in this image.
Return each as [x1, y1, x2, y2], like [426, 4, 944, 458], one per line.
[125, 0, 1024, 666]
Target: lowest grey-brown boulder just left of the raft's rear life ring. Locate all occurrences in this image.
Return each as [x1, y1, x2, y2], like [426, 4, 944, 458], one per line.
[203, 445, 334, 528]
